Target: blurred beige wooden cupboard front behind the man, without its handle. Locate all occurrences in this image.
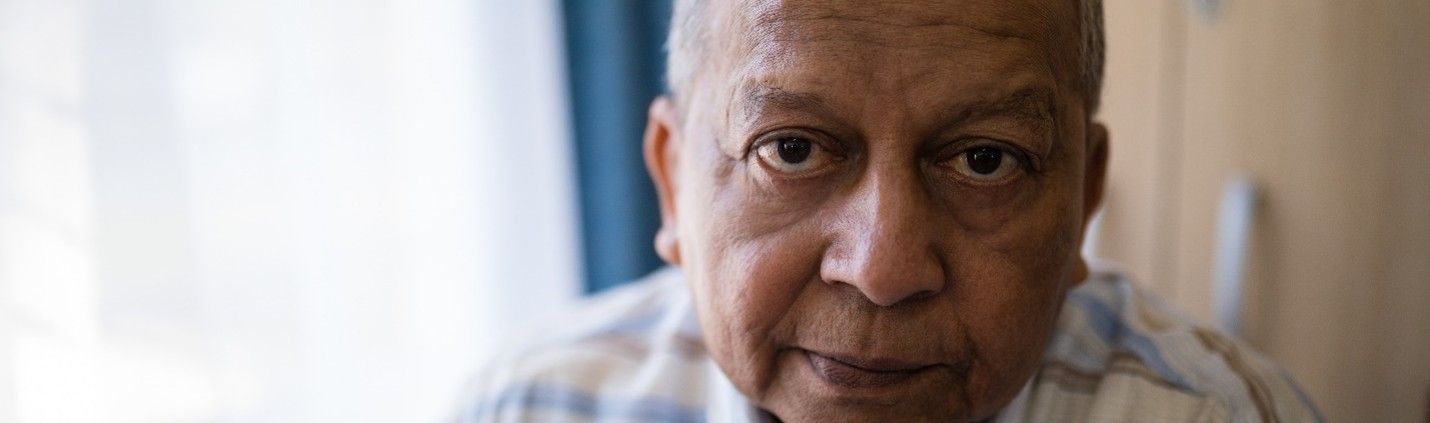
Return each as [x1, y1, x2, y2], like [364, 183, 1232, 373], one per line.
[1098, 0, 1430, 422]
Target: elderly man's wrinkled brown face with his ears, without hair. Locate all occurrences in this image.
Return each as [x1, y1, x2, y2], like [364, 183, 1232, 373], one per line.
[646, 0, 1104, 422]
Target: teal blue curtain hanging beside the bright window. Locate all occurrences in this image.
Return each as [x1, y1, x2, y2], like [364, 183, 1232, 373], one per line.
[562, 0, 671, 293]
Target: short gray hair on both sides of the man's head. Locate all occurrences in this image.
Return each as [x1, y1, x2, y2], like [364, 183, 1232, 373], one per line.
[665, 0, 1105, 116]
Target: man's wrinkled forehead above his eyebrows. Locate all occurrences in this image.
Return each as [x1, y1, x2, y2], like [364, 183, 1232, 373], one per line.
[694, 0, 1080, 120]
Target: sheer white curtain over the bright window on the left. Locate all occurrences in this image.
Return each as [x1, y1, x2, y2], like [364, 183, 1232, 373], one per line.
[0, 0, 581, 423]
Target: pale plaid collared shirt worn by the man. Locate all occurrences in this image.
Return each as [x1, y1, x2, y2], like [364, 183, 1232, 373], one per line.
[458, 269, 1321, 422]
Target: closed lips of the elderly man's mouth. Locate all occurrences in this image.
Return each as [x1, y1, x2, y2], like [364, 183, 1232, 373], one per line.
[805, 350, 935, 390]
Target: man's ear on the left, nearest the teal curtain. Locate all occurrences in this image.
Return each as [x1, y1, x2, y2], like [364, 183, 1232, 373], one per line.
[644, 96, 681, 266]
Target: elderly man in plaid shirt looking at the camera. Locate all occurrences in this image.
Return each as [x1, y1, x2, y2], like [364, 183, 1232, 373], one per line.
[462, 0, 1317, 422]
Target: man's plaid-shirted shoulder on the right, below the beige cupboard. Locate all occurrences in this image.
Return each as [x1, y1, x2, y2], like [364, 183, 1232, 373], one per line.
[1034, 266, 1321, 422]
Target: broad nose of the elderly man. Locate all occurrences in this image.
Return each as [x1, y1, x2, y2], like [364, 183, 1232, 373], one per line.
[819, 168, 945, 307]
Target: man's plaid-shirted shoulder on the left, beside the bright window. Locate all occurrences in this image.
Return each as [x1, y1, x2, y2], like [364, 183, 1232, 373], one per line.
[458, 269, 706, 422]
